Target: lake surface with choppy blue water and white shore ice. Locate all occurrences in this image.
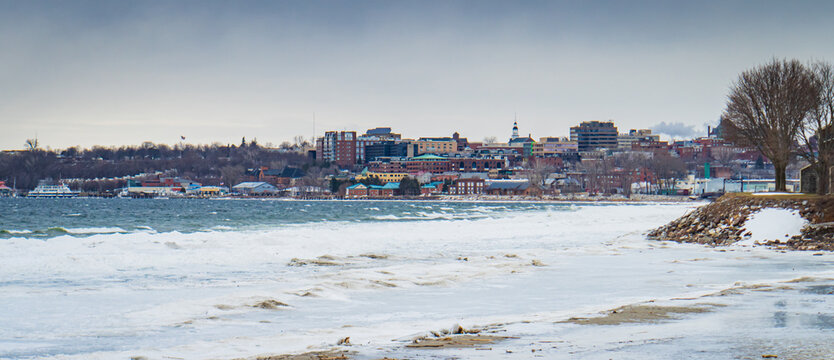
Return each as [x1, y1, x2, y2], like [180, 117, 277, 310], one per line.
[0, 199, 834, 359]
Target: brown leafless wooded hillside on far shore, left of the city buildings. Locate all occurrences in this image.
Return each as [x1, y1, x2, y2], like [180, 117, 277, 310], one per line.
[0, 141, 313, 191]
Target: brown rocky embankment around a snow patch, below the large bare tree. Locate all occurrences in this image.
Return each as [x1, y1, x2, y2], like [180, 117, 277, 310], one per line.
[647, 194, 834, 251]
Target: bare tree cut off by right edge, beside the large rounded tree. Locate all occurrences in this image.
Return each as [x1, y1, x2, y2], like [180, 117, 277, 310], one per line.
[798, 62, 834, 194]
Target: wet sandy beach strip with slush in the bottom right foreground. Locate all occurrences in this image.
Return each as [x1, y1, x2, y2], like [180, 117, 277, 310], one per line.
[235, 276, 834, 360]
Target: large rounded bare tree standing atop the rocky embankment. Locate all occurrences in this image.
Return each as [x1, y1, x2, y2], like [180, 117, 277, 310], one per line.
[723, 59, 817, 191]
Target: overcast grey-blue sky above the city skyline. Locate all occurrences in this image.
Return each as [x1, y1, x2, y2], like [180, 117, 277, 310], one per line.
[0, 0, 834, 149]
